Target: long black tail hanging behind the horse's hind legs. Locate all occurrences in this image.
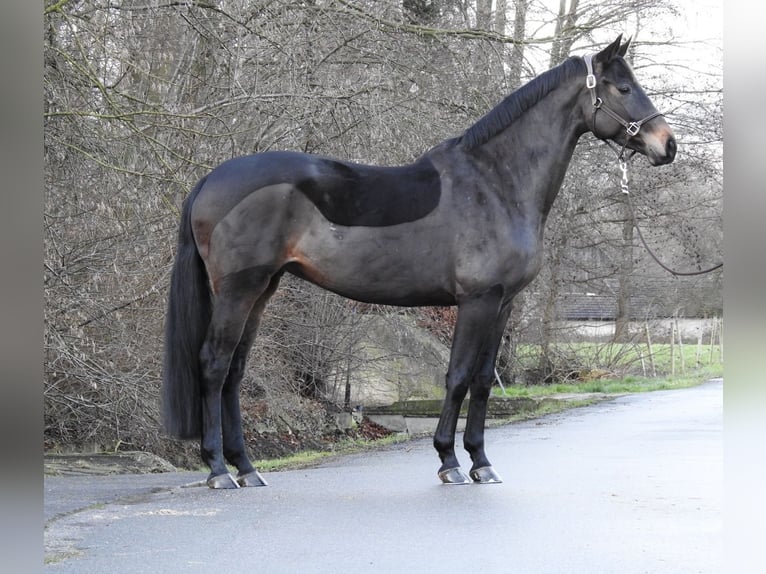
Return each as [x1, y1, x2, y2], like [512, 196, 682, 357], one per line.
[162, 179, 212, 439]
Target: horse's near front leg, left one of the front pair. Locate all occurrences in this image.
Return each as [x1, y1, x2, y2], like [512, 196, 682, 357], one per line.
[434, 289, 508, 484]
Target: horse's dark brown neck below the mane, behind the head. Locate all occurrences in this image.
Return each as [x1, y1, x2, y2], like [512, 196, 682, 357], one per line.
[482, 86, 586, 221]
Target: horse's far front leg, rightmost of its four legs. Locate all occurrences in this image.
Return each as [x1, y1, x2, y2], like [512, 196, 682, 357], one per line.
[463, 301, 511, 483]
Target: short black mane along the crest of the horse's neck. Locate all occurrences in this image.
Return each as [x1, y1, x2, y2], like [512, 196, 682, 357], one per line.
[457, 57, 584, 150]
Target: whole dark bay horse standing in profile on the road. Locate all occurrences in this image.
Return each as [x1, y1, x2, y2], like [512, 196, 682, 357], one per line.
[163, 36, 676, 488]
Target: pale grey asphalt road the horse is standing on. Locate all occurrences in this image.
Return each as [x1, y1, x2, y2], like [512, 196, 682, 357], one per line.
[45, 380, 723, 574]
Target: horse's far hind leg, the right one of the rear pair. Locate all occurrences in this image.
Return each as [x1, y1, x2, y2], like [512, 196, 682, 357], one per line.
[221, 275, 280, 486]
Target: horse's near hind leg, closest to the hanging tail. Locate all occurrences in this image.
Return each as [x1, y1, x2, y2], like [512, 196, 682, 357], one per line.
[200, 269, 271, 488]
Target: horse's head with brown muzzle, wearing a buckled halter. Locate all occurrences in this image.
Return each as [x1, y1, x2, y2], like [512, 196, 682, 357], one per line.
[584, 35, 676, 165]
